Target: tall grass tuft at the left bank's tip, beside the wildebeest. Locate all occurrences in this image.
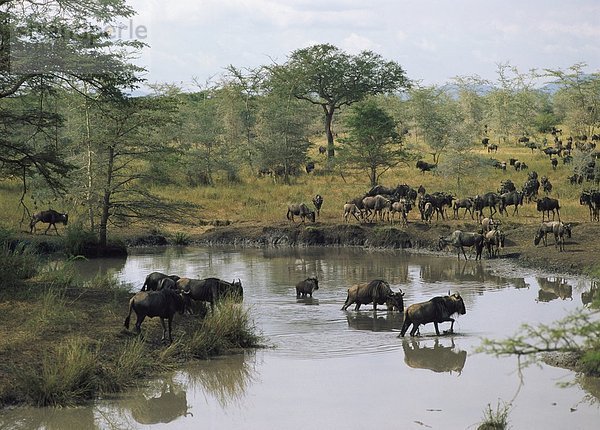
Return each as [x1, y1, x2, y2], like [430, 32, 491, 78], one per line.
[188, 299, 261, 358]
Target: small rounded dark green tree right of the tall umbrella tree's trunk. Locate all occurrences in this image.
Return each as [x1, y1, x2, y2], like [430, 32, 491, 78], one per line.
[340, 99, 408, 186]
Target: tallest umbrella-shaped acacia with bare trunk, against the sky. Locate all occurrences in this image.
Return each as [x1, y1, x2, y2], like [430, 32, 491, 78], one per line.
[271, 44, 409, 159]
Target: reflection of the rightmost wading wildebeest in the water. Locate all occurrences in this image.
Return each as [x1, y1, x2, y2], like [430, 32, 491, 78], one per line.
[402, 339, 467, 374]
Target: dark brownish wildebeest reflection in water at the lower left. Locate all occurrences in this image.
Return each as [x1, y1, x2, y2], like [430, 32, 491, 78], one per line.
[131, 382, 192, 424]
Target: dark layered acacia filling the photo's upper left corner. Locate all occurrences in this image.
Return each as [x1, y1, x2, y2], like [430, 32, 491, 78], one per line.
[0, 0, 141, 220]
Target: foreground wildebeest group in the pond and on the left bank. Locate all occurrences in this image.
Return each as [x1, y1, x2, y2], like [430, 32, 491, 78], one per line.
[123, 272, 466, 342]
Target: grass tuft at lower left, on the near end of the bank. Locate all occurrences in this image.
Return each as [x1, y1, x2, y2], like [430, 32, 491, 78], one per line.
[18, 338, 97, 406]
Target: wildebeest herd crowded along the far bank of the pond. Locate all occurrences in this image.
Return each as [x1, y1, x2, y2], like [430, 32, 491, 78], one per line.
[287, 171, 584, 255]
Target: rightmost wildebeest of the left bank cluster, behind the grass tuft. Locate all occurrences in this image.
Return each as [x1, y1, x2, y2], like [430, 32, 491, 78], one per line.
[177, 278, 244, 310]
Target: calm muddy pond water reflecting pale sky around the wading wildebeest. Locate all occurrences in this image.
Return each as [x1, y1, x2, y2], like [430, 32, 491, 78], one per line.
[0, 248, 600, 429]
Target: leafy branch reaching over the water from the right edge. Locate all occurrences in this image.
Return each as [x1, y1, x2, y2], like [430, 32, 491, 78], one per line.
[477, 309, 600, 375]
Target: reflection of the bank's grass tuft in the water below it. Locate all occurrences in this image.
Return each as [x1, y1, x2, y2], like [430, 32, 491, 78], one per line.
[186, 352, 256, 408]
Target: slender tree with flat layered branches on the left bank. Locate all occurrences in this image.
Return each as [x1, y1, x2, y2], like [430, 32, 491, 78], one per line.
[74, 96, 189, 246]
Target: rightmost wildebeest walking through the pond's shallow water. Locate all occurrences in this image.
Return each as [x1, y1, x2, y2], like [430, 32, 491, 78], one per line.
[400, 293, 467, 336]
